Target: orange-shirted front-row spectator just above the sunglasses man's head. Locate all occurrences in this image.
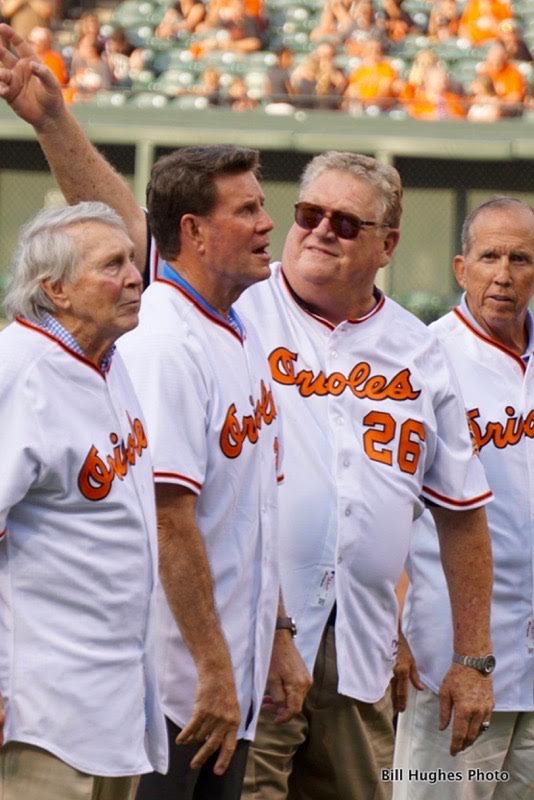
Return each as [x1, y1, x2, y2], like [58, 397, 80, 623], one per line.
[344, 39, 399, 111]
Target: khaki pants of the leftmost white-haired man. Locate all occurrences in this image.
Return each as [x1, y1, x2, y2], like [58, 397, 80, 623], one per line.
[0, 742, 140, 800]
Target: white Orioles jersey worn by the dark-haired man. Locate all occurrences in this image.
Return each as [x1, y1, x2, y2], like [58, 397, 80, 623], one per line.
[119, 272, 279, 738]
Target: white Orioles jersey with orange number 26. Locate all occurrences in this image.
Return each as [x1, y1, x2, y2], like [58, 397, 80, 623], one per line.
[237, 264, 491, 702]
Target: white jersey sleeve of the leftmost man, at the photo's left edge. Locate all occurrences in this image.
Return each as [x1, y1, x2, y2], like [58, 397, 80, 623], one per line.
[0, 372, 45, 539]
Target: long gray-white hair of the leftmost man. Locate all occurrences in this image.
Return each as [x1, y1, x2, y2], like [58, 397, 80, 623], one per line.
[4, 202, 128, 322]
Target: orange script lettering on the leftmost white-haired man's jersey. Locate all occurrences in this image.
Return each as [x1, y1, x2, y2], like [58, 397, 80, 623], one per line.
[78, 415, 148, 500]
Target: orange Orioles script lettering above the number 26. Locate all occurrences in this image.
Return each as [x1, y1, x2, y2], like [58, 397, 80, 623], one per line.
[269, 347, 421, 401]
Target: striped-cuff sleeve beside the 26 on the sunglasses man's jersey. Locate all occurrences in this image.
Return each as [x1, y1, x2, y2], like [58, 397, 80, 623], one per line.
[422, 334, 493, 510]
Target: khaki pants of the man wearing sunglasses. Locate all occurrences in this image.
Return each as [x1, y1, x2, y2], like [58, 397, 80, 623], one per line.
[241, 625, 393, 800]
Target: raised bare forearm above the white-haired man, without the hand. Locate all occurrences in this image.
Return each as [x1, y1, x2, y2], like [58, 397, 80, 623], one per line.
[35, 106, 147, 270]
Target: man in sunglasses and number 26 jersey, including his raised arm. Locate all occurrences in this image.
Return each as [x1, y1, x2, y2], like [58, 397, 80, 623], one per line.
[0, 30, 493, 800]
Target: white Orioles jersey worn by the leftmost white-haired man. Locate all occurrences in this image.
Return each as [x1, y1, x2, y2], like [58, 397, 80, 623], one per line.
[0, 320, 167, 776]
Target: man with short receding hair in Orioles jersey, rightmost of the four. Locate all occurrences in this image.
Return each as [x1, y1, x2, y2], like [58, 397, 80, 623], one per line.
[395, 197, 534, 800]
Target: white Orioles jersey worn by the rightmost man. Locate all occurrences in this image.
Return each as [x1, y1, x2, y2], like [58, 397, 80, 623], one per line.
[404, 305, 534, 711]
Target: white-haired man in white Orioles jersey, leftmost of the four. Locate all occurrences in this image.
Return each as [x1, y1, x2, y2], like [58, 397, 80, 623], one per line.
[0, 203, 167, 800]
